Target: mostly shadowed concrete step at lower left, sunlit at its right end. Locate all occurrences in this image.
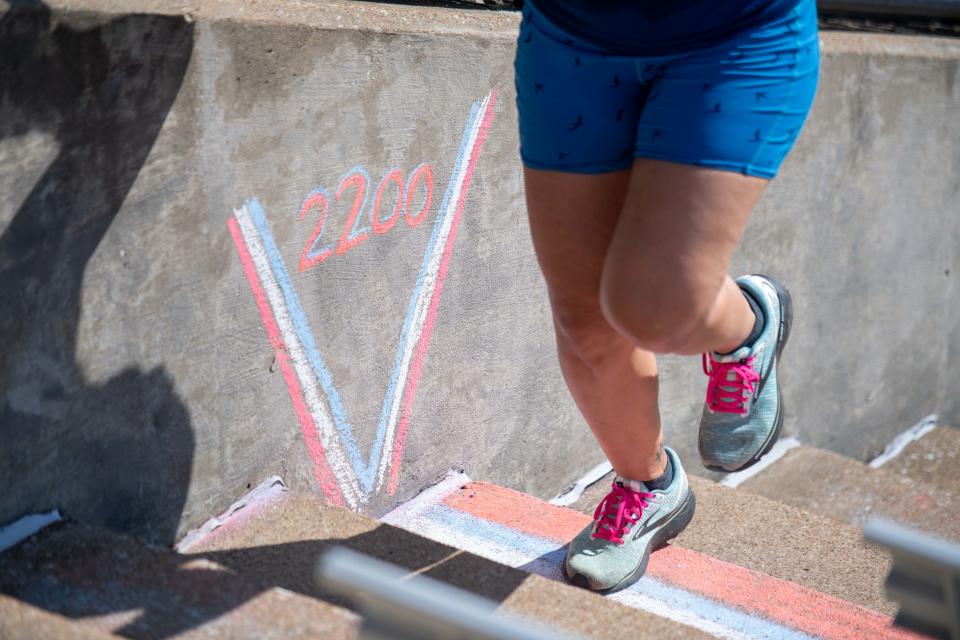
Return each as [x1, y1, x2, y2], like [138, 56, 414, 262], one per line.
[0, 522, 358, 640]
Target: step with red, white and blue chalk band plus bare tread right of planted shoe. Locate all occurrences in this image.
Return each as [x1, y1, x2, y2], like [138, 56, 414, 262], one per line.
[383, 474, 914, 639]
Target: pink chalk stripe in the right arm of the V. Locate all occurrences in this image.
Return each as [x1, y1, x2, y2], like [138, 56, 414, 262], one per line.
[387, 92, 497, 495]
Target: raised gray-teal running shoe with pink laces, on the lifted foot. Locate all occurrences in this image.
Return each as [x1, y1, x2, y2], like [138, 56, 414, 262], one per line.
[699, 275, 792, 472]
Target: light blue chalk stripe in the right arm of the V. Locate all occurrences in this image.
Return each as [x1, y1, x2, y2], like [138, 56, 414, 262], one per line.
[364, 100, 482, 486]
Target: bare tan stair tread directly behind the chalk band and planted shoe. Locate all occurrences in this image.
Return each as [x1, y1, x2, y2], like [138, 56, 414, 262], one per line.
[571, 473, 896, 615]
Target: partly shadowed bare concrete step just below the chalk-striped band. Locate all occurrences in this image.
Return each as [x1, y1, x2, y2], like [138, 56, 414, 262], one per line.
[180, 492, 711, 640]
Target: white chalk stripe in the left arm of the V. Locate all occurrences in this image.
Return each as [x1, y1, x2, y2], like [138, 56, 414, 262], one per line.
[234, 205, 366, 509]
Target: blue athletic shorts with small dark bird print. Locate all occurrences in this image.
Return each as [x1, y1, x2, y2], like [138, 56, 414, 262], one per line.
[514, 0, 820, 179]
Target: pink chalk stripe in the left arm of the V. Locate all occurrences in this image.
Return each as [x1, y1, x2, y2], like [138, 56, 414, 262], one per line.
[227, 217, 344, 506]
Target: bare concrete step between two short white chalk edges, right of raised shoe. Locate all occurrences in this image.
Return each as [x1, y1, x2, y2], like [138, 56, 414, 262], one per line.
[740, 446, 960, 540]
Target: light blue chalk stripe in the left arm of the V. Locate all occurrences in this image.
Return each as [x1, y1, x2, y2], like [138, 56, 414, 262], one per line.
[246, 198, 372, 484]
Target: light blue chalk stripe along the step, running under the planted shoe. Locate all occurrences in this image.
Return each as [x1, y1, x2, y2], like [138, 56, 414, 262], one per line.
[423, 505, 814, 640]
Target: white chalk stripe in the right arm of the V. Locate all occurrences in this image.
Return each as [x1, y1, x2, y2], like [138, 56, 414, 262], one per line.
[377, 94, 490, 490]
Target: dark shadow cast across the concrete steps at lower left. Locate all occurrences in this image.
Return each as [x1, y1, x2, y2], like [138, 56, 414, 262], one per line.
[0, 522, 529, 638]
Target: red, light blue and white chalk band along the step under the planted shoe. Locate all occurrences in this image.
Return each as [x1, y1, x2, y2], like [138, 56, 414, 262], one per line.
[383, 474, 916, 640]
